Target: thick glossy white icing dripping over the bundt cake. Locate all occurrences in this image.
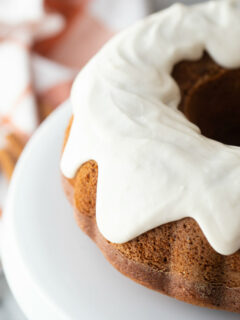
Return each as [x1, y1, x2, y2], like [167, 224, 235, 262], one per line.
[61, 0, 240, 254]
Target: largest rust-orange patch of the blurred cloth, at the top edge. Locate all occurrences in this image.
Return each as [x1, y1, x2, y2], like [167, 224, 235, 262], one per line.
[34, 0, 113, 69]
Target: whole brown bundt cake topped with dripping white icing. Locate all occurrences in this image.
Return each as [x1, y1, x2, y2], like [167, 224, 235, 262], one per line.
[61, 1, 240, 313]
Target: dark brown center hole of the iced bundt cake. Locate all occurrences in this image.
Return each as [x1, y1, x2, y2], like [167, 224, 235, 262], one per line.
[173, 53, 240, 146]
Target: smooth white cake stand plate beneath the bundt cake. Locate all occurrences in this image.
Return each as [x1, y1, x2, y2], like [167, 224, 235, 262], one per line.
[3, 103, 239, 320]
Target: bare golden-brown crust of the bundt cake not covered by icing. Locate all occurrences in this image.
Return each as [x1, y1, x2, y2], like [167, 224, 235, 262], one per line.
[63, 54, 240, 313]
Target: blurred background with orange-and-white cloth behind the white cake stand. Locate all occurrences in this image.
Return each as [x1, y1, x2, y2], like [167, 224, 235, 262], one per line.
[0, 0, 205, 320]
